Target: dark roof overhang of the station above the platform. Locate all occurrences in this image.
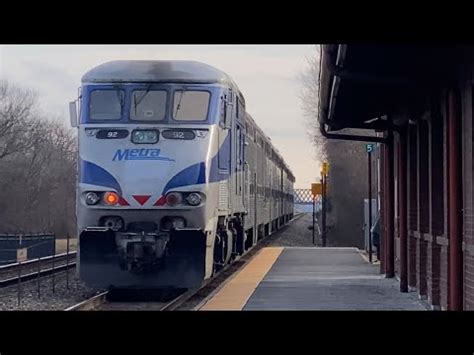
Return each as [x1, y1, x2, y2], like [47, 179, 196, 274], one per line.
[318, 44, 466, 131]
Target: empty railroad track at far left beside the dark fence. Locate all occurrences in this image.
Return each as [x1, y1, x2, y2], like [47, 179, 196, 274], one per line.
[0, 251, 76, 289]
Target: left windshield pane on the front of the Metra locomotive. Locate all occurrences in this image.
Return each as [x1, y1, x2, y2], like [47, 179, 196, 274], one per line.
[89, 90, 125, 120]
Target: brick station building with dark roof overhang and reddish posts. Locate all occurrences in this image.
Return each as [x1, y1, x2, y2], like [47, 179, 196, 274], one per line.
[318, 44, 474, 310]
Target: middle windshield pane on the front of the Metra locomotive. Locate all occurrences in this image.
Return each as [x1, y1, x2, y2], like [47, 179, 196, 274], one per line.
[130, 90, 167, 121]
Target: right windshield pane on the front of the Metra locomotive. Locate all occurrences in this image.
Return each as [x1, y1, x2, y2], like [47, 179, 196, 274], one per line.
[173, 90, 211, 121]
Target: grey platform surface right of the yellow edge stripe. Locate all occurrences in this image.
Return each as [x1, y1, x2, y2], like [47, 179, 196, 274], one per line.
[244, 247, 426, 311]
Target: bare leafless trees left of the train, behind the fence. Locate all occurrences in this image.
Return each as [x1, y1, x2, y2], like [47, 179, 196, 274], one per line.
[0, 81, 77, 237]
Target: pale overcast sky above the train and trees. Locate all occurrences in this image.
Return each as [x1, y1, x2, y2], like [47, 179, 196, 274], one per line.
[0, 45, 320, 188]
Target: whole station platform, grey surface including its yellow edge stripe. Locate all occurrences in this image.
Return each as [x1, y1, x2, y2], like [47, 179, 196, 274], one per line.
[199, 247, 426, 311]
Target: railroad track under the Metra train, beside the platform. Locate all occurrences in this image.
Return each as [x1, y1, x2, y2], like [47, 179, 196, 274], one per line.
[65, 213, 303, 311]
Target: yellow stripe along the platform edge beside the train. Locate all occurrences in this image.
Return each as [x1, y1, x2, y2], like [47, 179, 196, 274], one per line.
[199, 247, 283, 311]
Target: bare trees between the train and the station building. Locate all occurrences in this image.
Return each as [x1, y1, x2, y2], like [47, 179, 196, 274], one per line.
[300, 46, 367, 247]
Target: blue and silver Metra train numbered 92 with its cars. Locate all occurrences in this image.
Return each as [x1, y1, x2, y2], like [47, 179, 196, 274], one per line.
[69, 60, 295, 289]
